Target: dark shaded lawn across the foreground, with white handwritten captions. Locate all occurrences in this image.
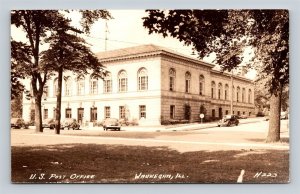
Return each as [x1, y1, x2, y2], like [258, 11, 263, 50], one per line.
[11, 144, 289, 183]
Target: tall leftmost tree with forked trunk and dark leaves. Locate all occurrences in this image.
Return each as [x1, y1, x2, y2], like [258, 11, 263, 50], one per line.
[11, 10, 110, 132]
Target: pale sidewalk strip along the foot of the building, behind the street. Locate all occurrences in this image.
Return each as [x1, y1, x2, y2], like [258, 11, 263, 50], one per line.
[82, 117, 263, 132]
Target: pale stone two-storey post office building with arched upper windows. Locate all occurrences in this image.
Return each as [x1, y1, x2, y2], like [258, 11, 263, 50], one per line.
[23, 45, 254, 125]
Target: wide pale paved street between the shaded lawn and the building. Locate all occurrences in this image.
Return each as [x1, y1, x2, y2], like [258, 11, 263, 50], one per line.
[11, 119, 289, 152]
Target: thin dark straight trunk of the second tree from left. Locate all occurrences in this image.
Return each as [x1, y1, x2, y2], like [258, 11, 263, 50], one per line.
[55, 66, 63, 134]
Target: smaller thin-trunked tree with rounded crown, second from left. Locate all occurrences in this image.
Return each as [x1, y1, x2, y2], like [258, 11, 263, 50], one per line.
[42, 24, 105, 134]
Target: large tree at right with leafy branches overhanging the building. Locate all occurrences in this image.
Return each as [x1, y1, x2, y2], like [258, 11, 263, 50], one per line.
[143, 10, 289, 142]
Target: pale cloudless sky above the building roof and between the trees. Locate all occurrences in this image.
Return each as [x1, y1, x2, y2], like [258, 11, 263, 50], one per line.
[11, 10, 256, 79]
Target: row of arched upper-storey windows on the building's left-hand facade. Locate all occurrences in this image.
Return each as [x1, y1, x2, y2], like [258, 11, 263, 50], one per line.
[44, 68, 148, 97]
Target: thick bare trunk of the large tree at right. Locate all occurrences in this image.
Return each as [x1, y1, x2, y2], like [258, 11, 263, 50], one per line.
[266, 91, 281, 142]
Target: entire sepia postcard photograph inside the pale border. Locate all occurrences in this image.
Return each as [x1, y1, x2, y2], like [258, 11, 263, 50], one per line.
[10, 9, 290, 184]
